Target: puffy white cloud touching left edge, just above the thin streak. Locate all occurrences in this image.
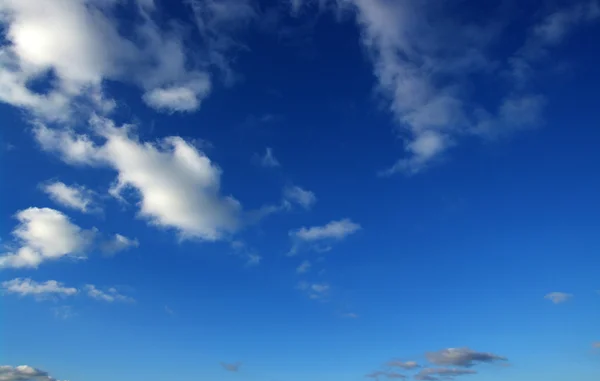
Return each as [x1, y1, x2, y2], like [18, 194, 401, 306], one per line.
[0, 208, 95, 268]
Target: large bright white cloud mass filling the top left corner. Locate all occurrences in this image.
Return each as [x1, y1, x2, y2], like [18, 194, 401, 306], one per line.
[0, 0, 253, 121]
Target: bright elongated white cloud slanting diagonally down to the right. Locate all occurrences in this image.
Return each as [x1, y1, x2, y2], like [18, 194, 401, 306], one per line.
[36, 117, 241, 241]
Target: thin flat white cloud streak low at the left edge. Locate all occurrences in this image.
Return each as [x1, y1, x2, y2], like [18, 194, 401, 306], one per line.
[2, 278, 134, 303]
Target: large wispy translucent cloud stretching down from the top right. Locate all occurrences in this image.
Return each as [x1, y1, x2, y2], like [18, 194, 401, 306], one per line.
[337, 0, 600, 175]
